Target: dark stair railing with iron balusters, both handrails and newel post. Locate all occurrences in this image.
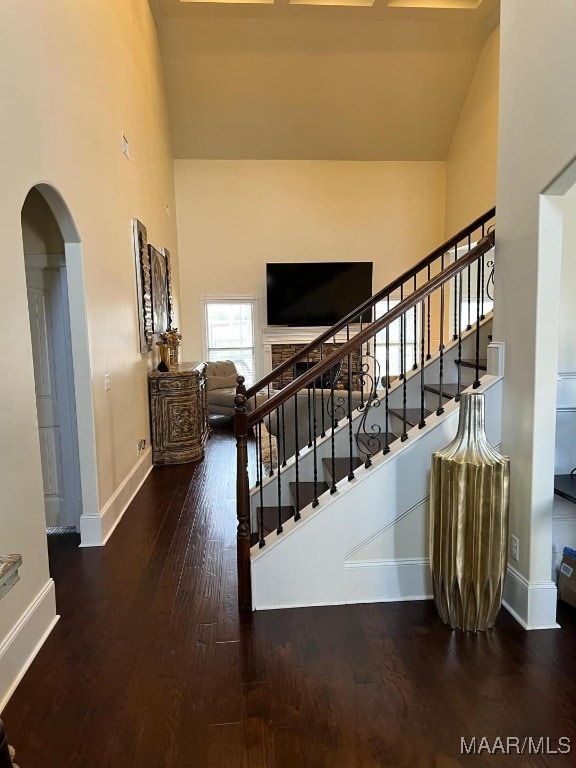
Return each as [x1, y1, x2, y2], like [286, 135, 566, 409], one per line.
[234, 209, 495, 608]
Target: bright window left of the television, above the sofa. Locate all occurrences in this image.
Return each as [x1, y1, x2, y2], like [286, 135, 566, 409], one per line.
[204, 297, 257, 387]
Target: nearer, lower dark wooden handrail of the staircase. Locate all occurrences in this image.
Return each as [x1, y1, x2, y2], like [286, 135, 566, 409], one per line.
[243, 231, 494, 428]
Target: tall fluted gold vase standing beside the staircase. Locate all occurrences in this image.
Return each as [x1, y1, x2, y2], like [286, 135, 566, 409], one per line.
[430, 392, 510, 632]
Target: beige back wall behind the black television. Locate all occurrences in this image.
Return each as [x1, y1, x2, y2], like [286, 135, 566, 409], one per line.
[175, 160, 445, 358]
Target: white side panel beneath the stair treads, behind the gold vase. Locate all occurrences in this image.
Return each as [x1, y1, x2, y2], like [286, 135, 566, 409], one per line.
[251, 375, 502, 610]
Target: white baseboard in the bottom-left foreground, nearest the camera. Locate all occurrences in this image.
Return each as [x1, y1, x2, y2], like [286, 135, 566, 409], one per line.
[0, 579, 60, 712]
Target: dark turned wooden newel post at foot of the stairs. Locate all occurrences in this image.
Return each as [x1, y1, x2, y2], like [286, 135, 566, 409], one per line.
[234, 376, 252, 610]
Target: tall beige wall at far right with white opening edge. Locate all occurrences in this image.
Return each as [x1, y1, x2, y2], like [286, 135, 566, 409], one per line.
[494, 0, 576, 625]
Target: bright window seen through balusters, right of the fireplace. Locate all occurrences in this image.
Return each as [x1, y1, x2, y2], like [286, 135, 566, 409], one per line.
[374, 298, 420, 379]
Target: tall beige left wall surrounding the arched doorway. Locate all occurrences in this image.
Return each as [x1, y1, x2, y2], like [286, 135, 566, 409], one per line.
[0, 0, 178, 700]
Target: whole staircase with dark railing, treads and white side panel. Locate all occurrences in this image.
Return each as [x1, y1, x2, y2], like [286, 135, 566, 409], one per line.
[235, 210, 499, 608]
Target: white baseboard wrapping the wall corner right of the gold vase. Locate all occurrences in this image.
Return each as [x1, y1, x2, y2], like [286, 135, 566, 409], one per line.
[502, 565, 559, 629]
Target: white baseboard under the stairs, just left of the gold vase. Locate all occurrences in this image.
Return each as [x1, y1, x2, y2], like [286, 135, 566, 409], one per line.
[344, 557, 432, 603]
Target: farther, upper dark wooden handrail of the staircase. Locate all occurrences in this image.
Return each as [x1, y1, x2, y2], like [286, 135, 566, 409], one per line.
[246, 208, 496, 399]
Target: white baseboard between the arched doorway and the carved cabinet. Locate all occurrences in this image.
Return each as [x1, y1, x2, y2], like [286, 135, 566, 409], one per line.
[80, 448, 152, 547]
